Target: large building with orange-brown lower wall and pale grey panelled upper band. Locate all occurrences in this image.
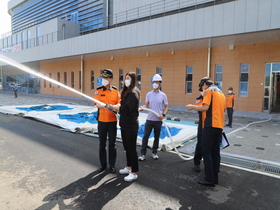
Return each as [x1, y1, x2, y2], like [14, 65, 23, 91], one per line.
[0, 0, 280, 112]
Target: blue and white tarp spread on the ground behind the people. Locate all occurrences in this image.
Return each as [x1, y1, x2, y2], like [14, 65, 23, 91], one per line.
[0, 103, 197, 150]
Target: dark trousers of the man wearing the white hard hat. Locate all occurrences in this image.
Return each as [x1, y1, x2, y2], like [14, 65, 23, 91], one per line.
[141, 120, 162, 155]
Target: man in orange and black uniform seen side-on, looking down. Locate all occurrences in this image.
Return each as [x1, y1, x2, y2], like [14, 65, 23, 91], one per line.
[186, 77, 226, 187]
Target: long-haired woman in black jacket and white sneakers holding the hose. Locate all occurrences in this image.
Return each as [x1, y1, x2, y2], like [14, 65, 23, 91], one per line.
[112, 72, 140, 182]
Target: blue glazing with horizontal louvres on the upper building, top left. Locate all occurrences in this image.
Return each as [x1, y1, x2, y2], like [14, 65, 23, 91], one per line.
[12, 0, 104, 33]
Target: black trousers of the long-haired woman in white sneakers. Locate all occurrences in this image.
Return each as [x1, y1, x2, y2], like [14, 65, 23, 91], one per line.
[121, 129, 139, 172]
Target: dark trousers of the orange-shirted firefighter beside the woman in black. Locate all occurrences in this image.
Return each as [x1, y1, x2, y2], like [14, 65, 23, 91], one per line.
[97, 122, 117, 167]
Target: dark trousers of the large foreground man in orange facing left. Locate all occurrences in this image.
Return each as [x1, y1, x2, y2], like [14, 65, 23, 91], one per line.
[201, 127, 223, 183]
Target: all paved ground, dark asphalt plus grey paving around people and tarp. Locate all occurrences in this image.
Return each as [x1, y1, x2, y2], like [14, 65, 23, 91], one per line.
[0, 91, 280, 210]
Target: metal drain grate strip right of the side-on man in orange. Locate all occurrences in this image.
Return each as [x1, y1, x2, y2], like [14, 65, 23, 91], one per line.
[221, 155, 280, 175]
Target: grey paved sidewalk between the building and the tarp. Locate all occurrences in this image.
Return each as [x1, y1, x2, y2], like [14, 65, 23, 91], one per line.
[0, 91, 280, 166]
